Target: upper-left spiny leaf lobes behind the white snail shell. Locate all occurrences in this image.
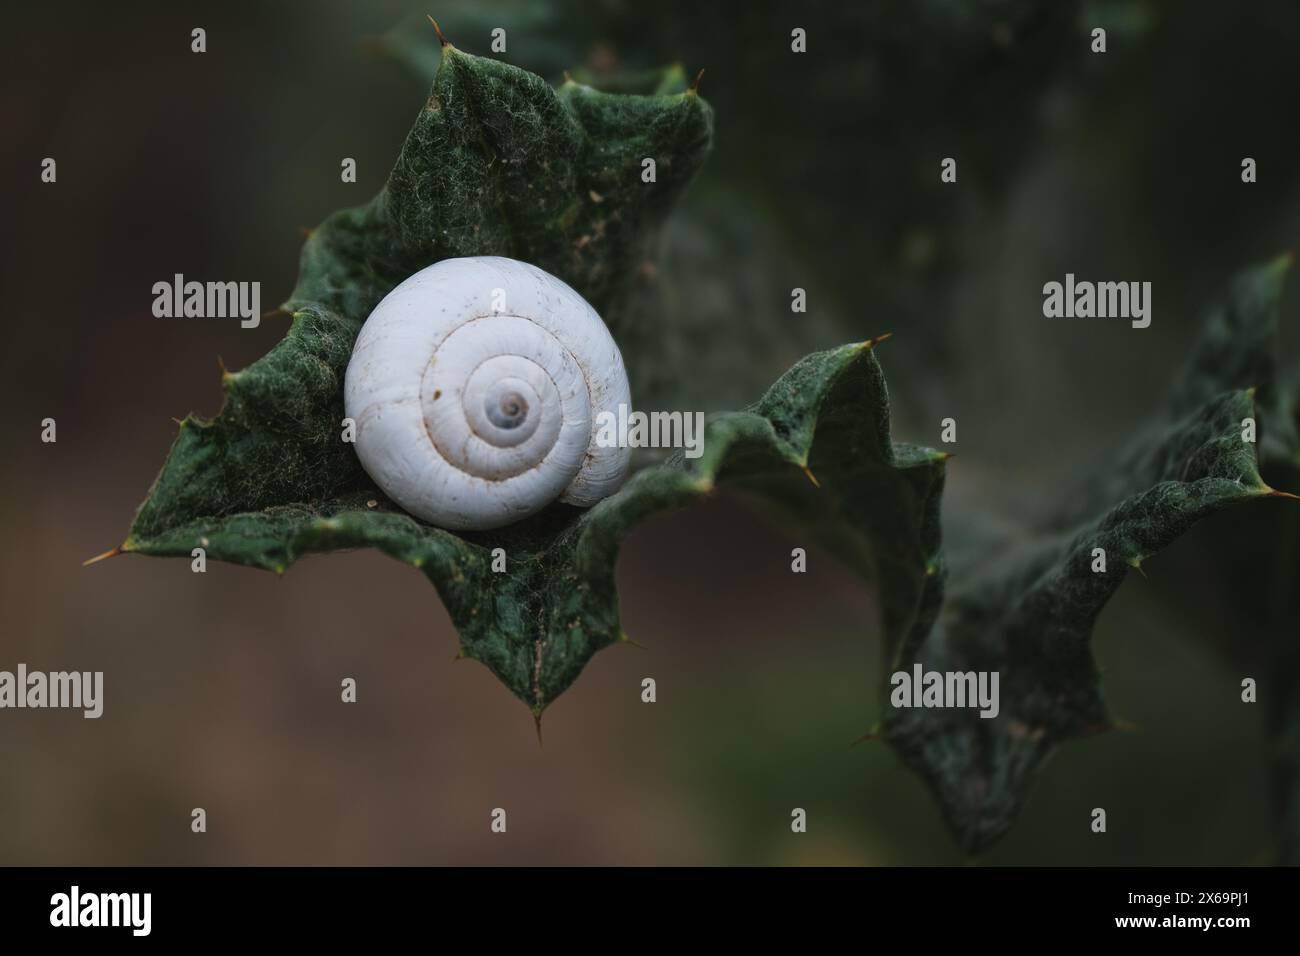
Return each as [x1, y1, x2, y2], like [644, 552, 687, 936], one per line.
[131, 46, 712, 540]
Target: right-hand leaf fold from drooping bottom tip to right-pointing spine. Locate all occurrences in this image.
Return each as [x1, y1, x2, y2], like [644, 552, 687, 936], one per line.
[885, 392, 1269, 851]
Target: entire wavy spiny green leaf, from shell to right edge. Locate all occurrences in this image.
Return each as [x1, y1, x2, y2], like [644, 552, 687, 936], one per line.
[104, 27, 1296, 849]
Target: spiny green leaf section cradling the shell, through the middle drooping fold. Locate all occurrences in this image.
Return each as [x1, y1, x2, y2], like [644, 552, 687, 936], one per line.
[116, 47, 944, 714]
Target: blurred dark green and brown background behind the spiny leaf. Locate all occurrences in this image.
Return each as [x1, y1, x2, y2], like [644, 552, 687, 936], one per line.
[0, 0, 1300, 864]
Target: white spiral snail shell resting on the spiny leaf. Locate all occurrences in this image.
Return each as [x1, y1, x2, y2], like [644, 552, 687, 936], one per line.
[343, 256, 631, 531]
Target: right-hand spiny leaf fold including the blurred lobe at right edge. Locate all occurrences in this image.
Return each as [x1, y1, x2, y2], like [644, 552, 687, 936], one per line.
[884, 258, 1290, 852]
